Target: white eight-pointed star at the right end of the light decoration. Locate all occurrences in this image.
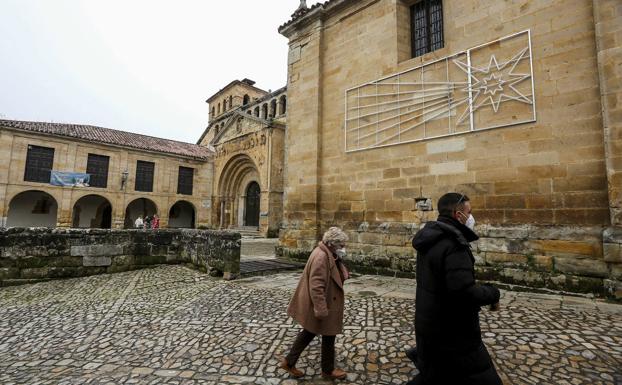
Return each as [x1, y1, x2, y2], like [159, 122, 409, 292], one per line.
[453, 48, 533, 124]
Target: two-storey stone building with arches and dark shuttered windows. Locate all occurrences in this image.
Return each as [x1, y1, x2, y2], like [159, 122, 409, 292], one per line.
[0, 120, 212, 228]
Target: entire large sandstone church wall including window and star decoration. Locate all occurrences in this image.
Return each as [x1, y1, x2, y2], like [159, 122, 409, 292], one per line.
[279, 0, 622, 295]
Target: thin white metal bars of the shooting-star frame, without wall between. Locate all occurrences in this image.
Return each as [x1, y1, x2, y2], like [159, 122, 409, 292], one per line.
[344, 29, 536, 152]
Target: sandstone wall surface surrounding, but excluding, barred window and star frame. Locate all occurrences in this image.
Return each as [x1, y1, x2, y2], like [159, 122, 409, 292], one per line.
[280, 0, 622, 294]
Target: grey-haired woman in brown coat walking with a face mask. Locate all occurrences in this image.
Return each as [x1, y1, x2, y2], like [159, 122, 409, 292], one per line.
[279, 227, 349, 379]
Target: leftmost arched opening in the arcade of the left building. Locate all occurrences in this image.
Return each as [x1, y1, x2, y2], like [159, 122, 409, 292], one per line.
[6, 191, 58, 227]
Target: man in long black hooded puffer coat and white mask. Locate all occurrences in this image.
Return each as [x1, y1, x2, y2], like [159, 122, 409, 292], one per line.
[408, 193, 502, 385]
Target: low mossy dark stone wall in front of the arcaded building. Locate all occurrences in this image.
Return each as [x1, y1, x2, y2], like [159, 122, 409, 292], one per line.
[0, 228, 240, 286]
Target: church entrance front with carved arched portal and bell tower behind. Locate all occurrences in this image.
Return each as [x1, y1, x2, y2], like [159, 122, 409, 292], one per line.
[198, 79, 287, 237]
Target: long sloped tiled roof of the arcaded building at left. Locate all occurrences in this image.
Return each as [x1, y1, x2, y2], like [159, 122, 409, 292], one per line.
[0, 119, 211, 160]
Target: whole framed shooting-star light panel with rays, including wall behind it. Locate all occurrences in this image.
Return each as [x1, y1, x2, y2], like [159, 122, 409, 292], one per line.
[344, 30, 536, 152]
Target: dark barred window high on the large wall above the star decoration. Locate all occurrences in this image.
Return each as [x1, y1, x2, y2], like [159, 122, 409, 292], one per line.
[410, 0, 444, 57]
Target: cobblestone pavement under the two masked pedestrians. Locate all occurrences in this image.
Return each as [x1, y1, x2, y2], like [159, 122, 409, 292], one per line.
[0, 266, 622, 385]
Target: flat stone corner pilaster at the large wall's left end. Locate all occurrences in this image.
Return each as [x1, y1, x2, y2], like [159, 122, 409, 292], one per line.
[281, 18, 323, 250]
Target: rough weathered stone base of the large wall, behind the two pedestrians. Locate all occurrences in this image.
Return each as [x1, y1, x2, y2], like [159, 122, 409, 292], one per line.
[277, 223, 622, 299]
